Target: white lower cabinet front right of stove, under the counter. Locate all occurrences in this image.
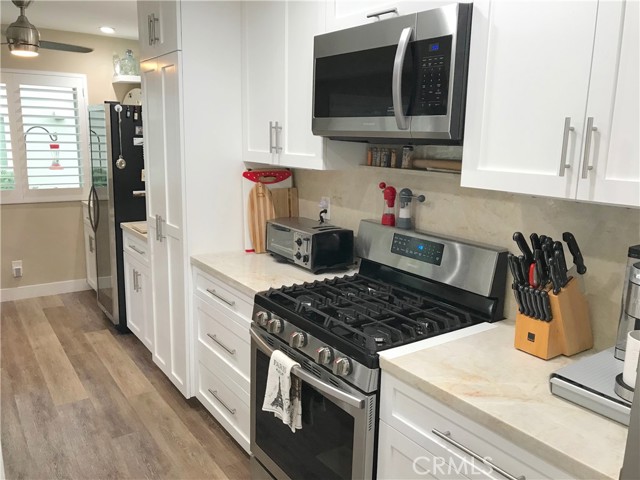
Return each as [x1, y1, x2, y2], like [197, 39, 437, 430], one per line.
[378, 372, 571, 480]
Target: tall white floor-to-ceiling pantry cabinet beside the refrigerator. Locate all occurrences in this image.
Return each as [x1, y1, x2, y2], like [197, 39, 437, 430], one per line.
[138, 1, 244, 397]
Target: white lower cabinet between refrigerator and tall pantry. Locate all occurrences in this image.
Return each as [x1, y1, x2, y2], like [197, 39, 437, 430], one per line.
[122, 230, 153, 350]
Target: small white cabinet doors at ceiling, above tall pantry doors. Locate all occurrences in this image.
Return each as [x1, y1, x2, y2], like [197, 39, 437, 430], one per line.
[138, 0, 181, 61]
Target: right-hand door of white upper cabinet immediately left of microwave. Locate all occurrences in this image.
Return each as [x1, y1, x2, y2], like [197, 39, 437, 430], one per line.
[276, 1, 324, 169]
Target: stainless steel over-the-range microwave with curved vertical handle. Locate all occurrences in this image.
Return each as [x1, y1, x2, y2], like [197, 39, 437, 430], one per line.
[312, 3, 473, 145]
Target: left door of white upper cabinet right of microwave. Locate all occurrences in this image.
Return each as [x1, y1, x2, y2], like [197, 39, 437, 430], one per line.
[461, 1, 598, 198]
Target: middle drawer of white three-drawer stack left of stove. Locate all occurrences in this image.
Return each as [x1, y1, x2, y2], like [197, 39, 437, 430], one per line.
[194, 297, 251, 391]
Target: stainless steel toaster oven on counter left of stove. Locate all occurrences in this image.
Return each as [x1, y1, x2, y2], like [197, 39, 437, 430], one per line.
[266, 217, 354, 273]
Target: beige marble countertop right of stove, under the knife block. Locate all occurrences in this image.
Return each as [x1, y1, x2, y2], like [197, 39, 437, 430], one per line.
[380, 320, 627, 479]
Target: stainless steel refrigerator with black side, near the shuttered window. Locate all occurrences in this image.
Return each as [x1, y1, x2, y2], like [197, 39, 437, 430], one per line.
[89, 102, 146, 332]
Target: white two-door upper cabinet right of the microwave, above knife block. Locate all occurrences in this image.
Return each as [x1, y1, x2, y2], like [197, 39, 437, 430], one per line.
[461, 1, 640, 206]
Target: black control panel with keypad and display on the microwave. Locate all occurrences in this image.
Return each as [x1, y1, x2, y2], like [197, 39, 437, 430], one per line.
[411, 35, 452, 115]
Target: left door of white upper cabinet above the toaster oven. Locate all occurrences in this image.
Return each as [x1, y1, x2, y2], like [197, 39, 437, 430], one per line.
[242, 1, 286, 163]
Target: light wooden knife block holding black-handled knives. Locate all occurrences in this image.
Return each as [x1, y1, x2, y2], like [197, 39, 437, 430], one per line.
[514, 278, 593, 360]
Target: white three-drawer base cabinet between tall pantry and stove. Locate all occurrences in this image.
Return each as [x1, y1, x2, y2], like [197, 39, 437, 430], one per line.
[192, 268, 253, 452]
